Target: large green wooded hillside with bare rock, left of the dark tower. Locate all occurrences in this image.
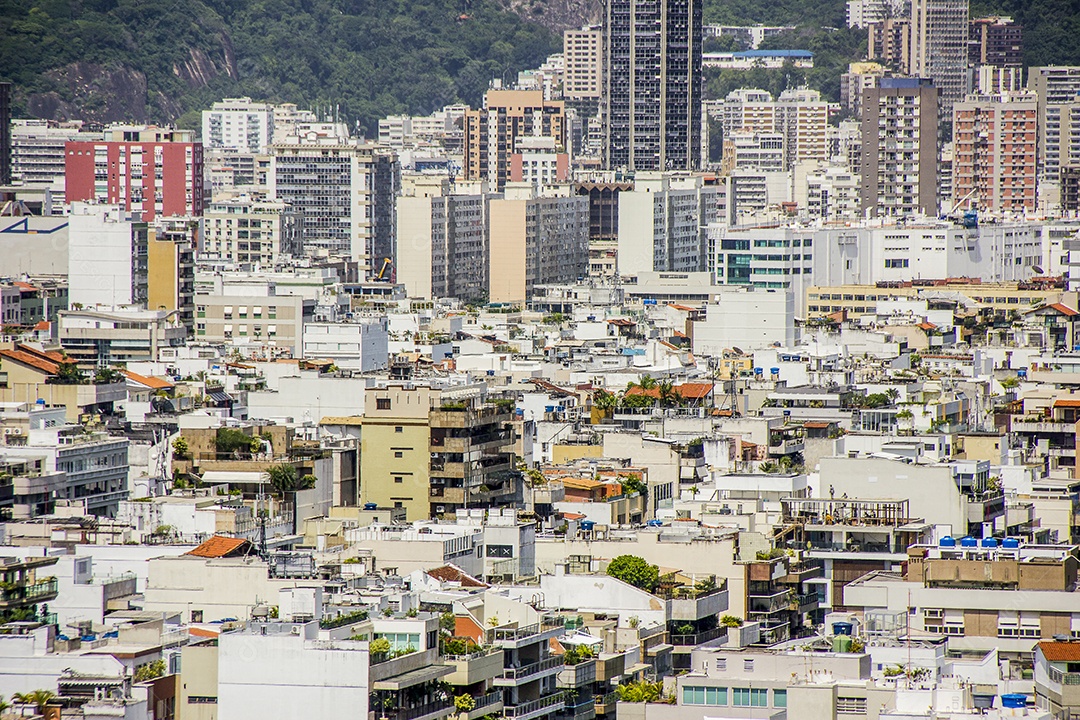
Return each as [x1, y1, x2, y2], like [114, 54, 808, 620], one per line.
[0, 0, 561, 133]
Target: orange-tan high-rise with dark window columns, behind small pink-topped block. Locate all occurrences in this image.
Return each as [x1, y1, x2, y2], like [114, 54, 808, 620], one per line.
[462, 90, 569, 190]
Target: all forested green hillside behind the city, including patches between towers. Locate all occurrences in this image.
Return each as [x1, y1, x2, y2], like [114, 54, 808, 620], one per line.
[6, 0, 1080, 132]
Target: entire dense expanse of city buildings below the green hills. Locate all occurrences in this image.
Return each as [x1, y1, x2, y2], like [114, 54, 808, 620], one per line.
[0, 0, 1080, 720]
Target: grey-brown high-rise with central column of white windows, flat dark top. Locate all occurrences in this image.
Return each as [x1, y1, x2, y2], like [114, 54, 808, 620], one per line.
[862, 78, 937, 217]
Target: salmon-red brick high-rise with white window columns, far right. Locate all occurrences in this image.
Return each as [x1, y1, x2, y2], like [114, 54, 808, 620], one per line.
[953, 95, 1038, 214]
